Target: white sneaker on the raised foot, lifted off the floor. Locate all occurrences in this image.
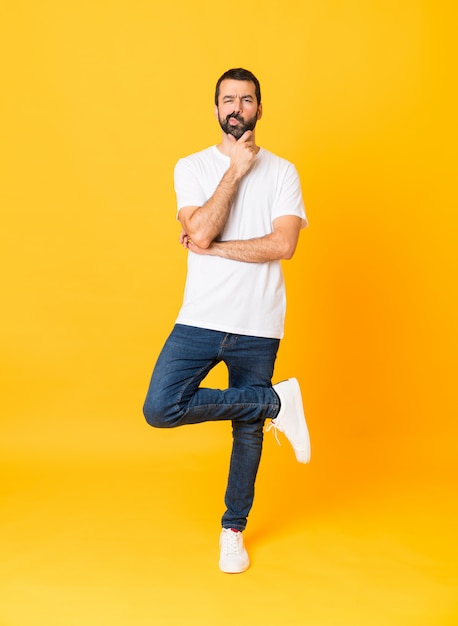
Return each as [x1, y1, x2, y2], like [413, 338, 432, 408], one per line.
[266, 378, 310, 463]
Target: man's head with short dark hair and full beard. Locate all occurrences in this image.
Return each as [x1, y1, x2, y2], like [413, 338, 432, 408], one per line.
[215, 68, 262, 139]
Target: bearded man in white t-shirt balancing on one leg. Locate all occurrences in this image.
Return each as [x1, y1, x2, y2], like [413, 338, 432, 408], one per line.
[144, 68, 310, 573]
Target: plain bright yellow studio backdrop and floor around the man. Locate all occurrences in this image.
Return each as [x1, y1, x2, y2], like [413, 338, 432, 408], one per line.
[0, 0, 458, 626]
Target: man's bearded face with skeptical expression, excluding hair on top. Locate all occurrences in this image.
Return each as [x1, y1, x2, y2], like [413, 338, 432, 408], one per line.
[215, 79, 262, 139]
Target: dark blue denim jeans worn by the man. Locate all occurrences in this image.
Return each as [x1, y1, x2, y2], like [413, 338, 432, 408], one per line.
[143, 324, 280, 530]
